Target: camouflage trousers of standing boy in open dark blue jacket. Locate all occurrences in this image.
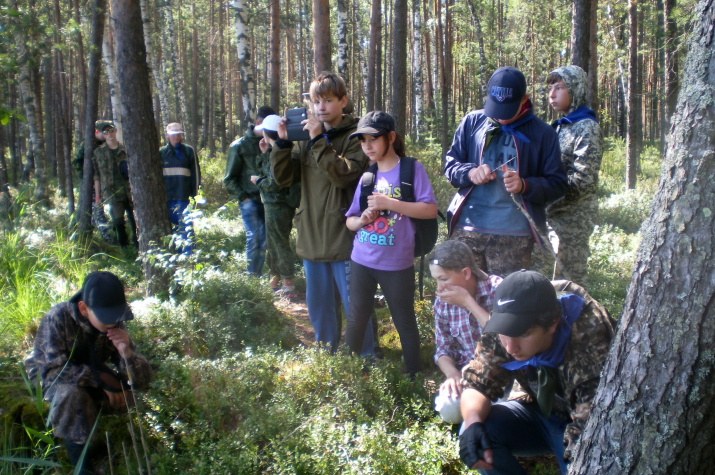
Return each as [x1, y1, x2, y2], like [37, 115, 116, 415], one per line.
[450, 228, 534, 277]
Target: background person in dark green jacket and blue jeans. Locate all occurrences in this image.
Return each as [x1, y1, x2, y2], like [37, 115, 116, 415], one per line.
[223, 106, 275, 276]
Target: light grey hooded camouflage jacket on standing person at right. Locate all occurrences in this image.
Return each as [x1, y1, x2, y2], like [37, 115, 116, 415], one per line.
[548, 66, 603, 216]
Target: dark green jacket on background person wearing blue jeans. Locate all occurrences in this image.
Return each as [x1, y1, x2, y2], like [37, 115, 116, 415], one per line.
[223, 126, 261, 203]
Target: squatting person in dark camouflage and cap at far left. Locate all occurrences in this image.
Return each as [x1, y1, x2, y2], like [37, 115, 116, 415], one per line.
[25, 272, 152, 473]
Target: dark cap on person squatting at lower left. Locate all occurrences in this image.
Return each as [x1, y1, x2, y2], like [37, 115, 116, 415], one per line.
[73, 271, 134, 325]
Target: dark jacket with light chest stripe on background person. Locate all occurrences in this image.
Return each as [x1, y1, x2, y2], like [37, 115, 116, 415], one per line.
[159, 144, 201, 201]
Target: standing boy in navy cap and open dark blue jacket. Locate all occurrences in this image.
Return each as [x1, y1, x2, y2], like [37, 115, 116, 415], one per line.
[444, 67, 567, 276]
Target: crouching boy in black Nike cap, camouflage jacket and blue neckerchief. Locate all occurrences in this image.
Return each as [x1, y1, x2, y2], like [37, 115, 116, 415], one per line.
[459, 270, 613, 475]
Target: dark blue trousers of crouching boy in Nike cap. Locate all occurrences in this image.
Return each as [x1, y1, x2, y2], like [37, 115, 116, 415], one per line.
[479, 401, 567, 475]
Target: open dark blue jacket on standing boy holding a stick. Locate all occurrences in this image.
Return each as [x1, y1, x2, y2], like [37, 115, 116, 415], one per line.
[444, 106, 568, 242]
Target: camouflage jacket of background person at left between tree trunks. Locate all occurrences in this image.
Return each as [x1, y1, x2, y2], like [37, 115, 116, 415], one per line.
[92, 143, 131, 205]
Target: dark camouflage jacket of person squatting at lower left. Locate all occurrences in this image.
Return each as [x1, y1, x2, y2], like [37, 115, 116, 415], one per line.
[25, 294, 152, 398]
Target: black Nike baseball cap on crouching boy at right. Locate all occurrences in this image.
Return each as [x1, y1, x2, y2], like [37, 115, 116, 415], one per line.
[484, 269, 560, 338]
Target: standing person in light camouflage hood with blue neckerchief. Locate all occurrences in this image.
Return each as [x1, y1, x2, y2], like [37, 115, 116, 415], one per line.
[546, 65, 603, 286]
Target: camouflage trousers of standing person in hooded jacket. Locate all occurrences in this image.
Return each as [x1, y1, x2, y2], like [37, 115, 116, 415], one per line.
[548, 211, 596, 287]
